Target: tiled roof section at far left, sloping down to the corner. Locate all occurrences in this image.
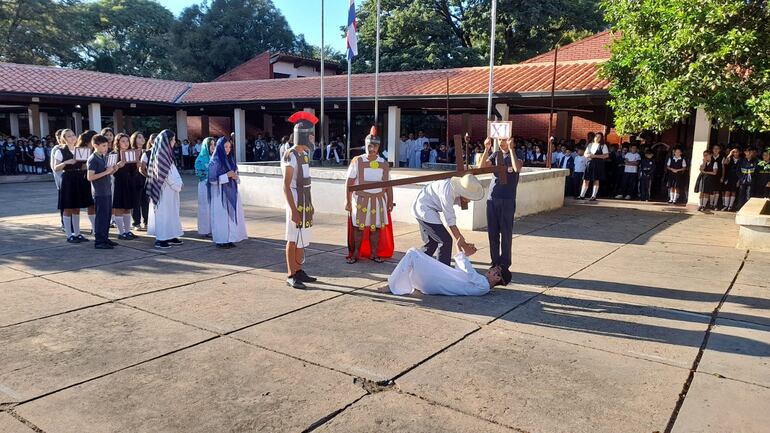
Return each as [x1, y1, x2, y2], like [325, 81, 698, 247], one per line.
[0, 63, 190, 103]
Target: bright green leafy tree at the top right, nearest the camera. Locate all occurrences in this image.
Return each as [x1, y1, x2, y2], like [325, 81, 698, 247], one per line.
[602, 0, 770, 133]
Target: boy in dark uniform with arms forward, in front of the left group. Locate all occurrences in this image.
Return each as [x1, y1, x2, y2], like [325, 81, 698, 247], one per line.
[86, 135, 125, 250]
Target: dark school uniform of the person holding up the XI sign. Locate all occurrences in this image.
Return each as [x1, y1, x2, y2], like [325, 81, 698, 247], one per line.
[487, 152, 519, 269]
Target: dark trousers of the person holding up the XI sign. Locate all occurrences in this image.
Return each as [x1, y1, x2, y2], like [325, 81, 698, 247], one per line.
[487, 198, 516, 269]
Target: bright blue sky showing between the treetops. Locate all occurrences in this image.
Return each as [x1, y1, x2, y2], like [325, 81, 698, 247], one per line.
[165, 0, 352, 52]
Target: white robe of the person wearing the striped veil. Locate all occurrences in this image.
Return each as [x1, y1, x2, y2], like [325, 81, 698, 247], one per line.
[147, 164, 184, 241]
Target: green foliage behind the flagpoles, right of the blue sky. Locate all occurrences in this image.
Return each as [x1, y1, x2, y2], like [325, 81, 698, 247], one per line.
[352, 0, 604, 72]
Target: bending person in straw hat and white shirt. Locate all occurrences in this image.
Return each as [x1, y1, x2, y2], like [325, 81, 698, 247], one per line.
[412, 174, 485, 266]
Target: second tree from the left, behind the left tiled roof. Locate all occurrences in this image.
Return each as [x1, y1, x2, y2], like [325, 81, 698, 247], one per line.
[73, 0, 175, 78]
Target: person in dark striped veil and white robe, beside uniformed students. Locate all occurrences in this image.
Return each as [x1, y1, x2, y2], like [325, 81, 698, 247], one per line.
[147, 129, 184, 249]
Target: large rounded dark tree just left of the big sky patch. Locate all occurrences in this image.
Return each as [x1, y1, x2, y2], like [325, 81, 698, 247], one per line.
[171, 0, 296, 81]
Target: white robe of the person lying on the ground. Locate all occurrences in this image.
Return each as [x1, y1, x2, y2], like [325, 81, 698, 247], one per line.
[388, 248, 489, 296]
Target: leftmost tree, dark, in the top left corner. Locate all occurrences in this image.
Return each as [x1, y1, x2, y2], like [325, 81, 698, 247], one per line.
[0, 0, 90, 65]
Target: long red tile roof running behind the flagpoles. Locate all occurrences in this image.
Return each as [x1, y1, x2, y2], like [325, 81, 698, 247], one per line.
[180, 62, 609, 104]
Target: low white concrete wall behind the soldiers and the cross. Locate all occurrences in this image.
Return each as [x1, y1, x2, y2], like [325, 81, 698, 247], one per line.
[238, 164, 569, 230]
